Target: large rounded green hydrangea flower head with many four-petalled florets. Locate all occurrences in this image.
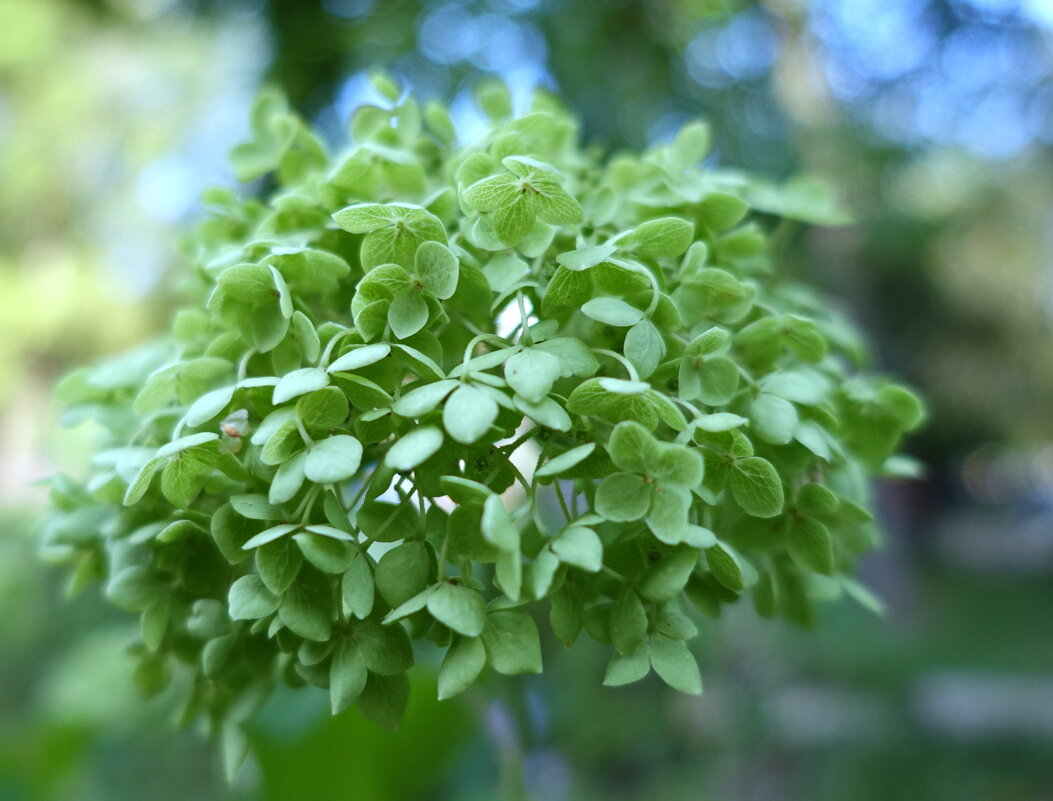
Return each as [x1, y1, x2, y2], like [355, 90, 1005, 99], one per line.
[46, 81, 921, 766]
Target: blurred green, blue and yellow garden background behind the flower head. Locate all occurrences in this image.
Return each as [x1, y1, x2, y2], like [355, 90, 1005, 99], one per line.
[0, 0, 1053, 801]
